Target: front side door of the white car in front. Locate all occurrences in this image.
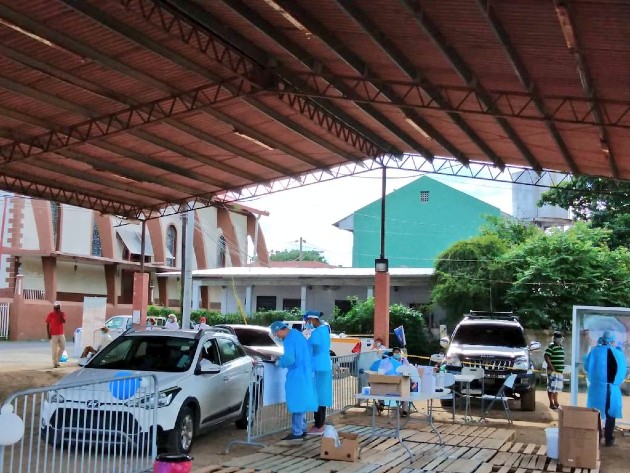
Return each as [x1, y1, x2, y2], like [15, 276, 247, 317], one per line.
[200, 339, 228, 426]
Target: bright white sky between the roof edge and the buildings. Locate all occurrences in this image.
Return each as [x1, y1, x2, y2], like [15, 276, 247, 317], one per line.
[243, 169, 512, 267]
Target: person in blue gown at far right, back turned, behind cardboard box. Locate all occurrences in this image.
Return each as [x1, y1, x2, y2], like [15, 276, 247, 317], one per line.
[584, 330, 626, 447]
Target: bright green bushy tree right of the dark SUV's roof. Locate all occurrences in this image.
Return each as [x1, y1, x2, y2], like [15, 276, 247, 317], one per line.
[502, 223, 630, 329]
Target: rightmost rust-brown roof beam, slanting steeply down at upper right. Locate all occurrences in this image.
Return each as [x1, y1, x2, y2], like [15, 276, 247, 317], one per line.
[554, 0, 619, 179]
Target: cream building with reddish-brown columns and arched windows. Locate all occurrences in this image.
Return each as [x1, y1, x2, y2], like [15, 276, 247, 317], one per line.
[0, 195, 269, 339]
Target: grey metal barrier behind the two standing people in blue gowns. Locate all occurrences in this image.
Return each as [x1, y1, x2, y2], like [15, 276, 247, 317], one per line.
[226, 351, 379, 453]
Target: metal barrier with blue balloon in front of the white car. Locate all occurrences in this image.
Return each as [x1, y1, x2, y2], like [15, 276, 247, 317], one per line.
[0, 372, 158, 473]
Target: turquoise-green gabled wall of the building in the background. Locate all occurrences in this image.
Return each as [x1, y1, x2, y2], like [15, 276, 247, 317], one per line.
[352, 176, 501, 268]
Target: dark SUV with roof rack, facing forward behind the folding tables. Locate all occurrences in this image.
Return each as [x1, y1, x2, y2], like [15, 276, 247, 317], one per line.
[444, 311, 540, 411]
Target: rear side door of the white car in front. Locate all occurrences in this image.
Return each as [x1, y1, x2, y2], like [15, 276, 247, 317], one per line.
[216, 337, 252, 413]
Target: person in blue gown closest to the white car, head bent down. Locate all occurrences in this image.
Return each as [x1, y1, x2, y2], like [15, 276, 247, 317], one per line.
[269, 321, 317, 440]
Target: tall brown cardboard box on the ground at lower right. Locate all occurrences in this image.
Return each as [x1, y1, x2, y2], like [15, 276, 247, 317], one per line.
[558, 406, 601, 468]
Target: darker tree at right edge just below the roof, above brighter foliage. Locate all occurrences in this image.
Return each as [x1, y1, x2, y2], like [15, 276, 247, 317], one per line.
[538, 176, 630, 248]
